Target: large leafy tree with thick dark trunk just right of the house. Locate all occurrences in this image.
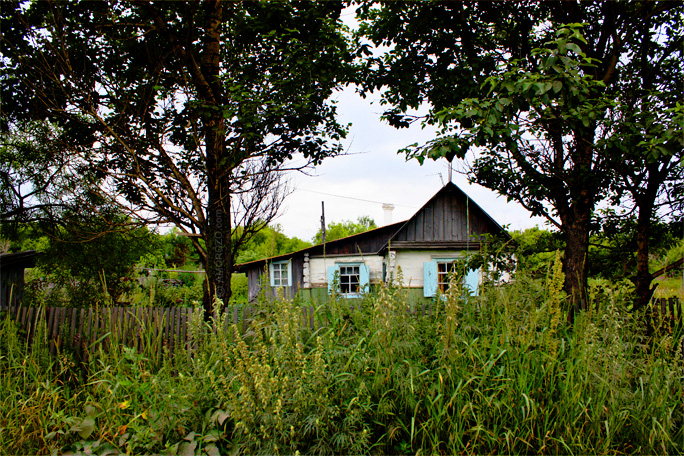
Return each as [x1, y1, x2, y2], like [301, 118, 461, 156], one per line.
[361, 1, 682, 309]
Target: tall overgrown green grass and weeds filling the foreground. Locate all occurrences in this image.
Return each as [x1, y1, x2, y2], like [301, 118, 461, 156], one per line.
[0, 262, 684, 455]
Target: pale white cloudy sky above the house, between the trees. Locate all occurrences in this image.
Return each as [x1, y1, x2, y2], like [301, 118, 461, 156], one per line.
[274, 84, 546, 241]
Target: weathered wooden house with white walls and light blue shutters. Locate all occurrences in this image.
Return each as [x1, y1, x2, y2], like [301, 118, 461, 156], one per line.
[236, 182, 508, 301]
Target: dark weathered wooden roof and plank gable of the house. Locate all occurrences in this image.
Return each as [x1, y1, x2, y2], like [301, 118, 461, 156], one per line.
[235, 182, 510, 272]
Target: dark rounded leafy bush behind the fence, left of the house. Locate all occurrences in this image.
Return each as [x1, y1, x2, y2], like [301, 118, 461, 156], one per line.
[13, 210, 157, 307]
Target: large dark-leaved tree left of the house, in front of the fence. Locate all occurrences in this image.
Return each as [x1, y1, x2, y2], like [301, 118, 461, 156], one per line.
[0, 0, 349, 311]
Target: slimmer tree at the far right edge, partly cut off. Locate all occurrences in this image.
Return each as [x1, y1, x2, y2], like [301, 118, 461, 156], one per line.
[608, 7, 684, 309]
